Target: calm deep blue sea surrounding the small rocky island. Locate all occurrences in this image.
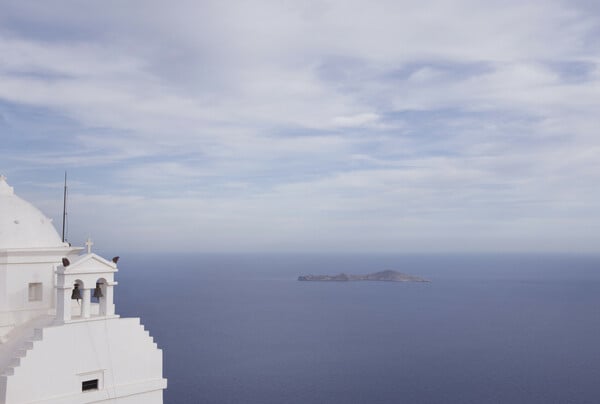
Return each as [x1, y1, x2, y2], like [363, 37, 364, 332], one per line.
[116, 254, 600, 404]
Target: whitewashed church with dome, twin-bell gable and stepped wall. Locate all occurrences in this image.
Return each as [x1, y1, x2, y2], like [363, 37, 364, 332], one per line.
[0, 176, 167, 404]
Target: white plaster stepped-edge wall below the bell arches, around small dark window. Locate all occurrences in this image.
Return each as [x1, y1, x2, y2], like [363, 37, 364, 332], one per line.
[2, 318, 166, 404]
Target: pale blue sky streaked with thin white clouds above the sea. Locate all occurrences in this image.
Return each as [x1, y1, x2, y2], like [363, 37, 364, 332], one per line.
[0, 0, 600, 253]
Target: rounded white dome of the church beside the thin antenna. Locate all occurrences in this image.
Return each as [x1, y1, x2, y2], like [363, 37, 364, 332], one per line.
[0, 176, 65, 250]
